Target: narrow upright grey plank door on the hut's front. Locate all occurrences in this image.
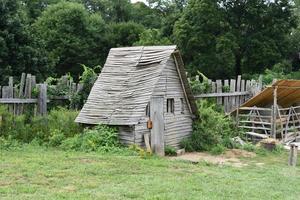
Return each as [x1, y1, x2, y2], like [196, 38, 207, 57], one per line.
[150, 96, 165, 156]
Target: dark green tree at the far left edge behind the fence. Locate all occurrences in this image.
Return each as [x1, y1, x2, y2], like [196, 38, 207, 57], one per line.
[0, 0, 51, 83]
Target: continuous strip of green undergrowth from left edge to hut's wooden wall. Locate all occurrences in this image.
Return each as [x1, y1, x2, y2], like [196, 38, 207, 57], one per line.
[0, 107, 121, 151]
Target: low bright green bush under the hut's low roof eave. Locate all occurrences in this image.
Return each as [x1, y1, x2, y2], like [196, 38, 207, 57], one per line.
[61, 125, 121, 151]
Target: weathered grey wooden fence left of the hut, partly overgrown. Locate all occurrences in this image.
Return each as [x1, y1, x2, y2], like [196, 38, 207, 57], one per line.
[0, 73, 82, 116]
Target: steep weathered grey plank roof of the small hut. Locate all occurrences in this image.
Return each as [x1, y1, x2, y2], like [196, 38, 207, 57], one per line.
[76, 46, 197, 125]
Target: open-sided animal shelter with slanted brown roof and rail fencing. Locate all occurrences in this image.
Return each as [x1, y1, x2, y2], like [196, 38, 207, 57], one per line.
[234, 80, 300, 143]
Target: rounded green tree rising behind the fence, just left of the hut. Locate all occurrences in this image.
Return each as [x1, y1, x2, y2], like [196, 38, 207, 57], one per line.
[34, 2, 109, 76]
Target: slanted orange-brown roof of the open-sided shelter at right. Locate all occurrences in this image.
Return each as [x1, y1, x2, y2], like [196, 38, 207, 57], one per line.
[241, 80, 300, 107]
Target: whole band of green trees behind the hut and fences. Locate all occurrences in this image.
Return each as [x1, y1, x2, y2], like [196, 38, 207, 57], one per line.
[0, 0, 300, 83]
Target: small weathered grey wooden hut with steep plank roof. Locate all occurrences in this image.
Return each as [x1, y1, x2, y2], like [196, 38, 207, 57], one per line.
[76, 46, 197, 154]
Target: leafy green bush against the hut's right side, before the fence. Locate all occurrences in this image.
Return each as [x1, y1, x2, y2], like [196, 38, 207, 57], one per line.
[181, 100, 238, 151]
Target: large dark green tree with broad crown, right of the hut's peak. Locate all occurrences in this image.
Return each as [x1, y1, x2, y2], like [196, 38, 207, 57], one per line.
[174, 0, 295, 78]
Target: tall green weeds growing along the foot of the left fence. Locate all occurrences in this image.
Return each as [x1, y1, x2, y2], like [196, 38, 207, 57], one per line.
[0, 106, 83, 145]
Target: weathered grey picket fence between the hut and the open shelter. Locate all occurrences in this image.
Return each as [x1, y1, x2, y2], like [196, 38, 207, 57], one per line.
[195, 76, 262, 113]
